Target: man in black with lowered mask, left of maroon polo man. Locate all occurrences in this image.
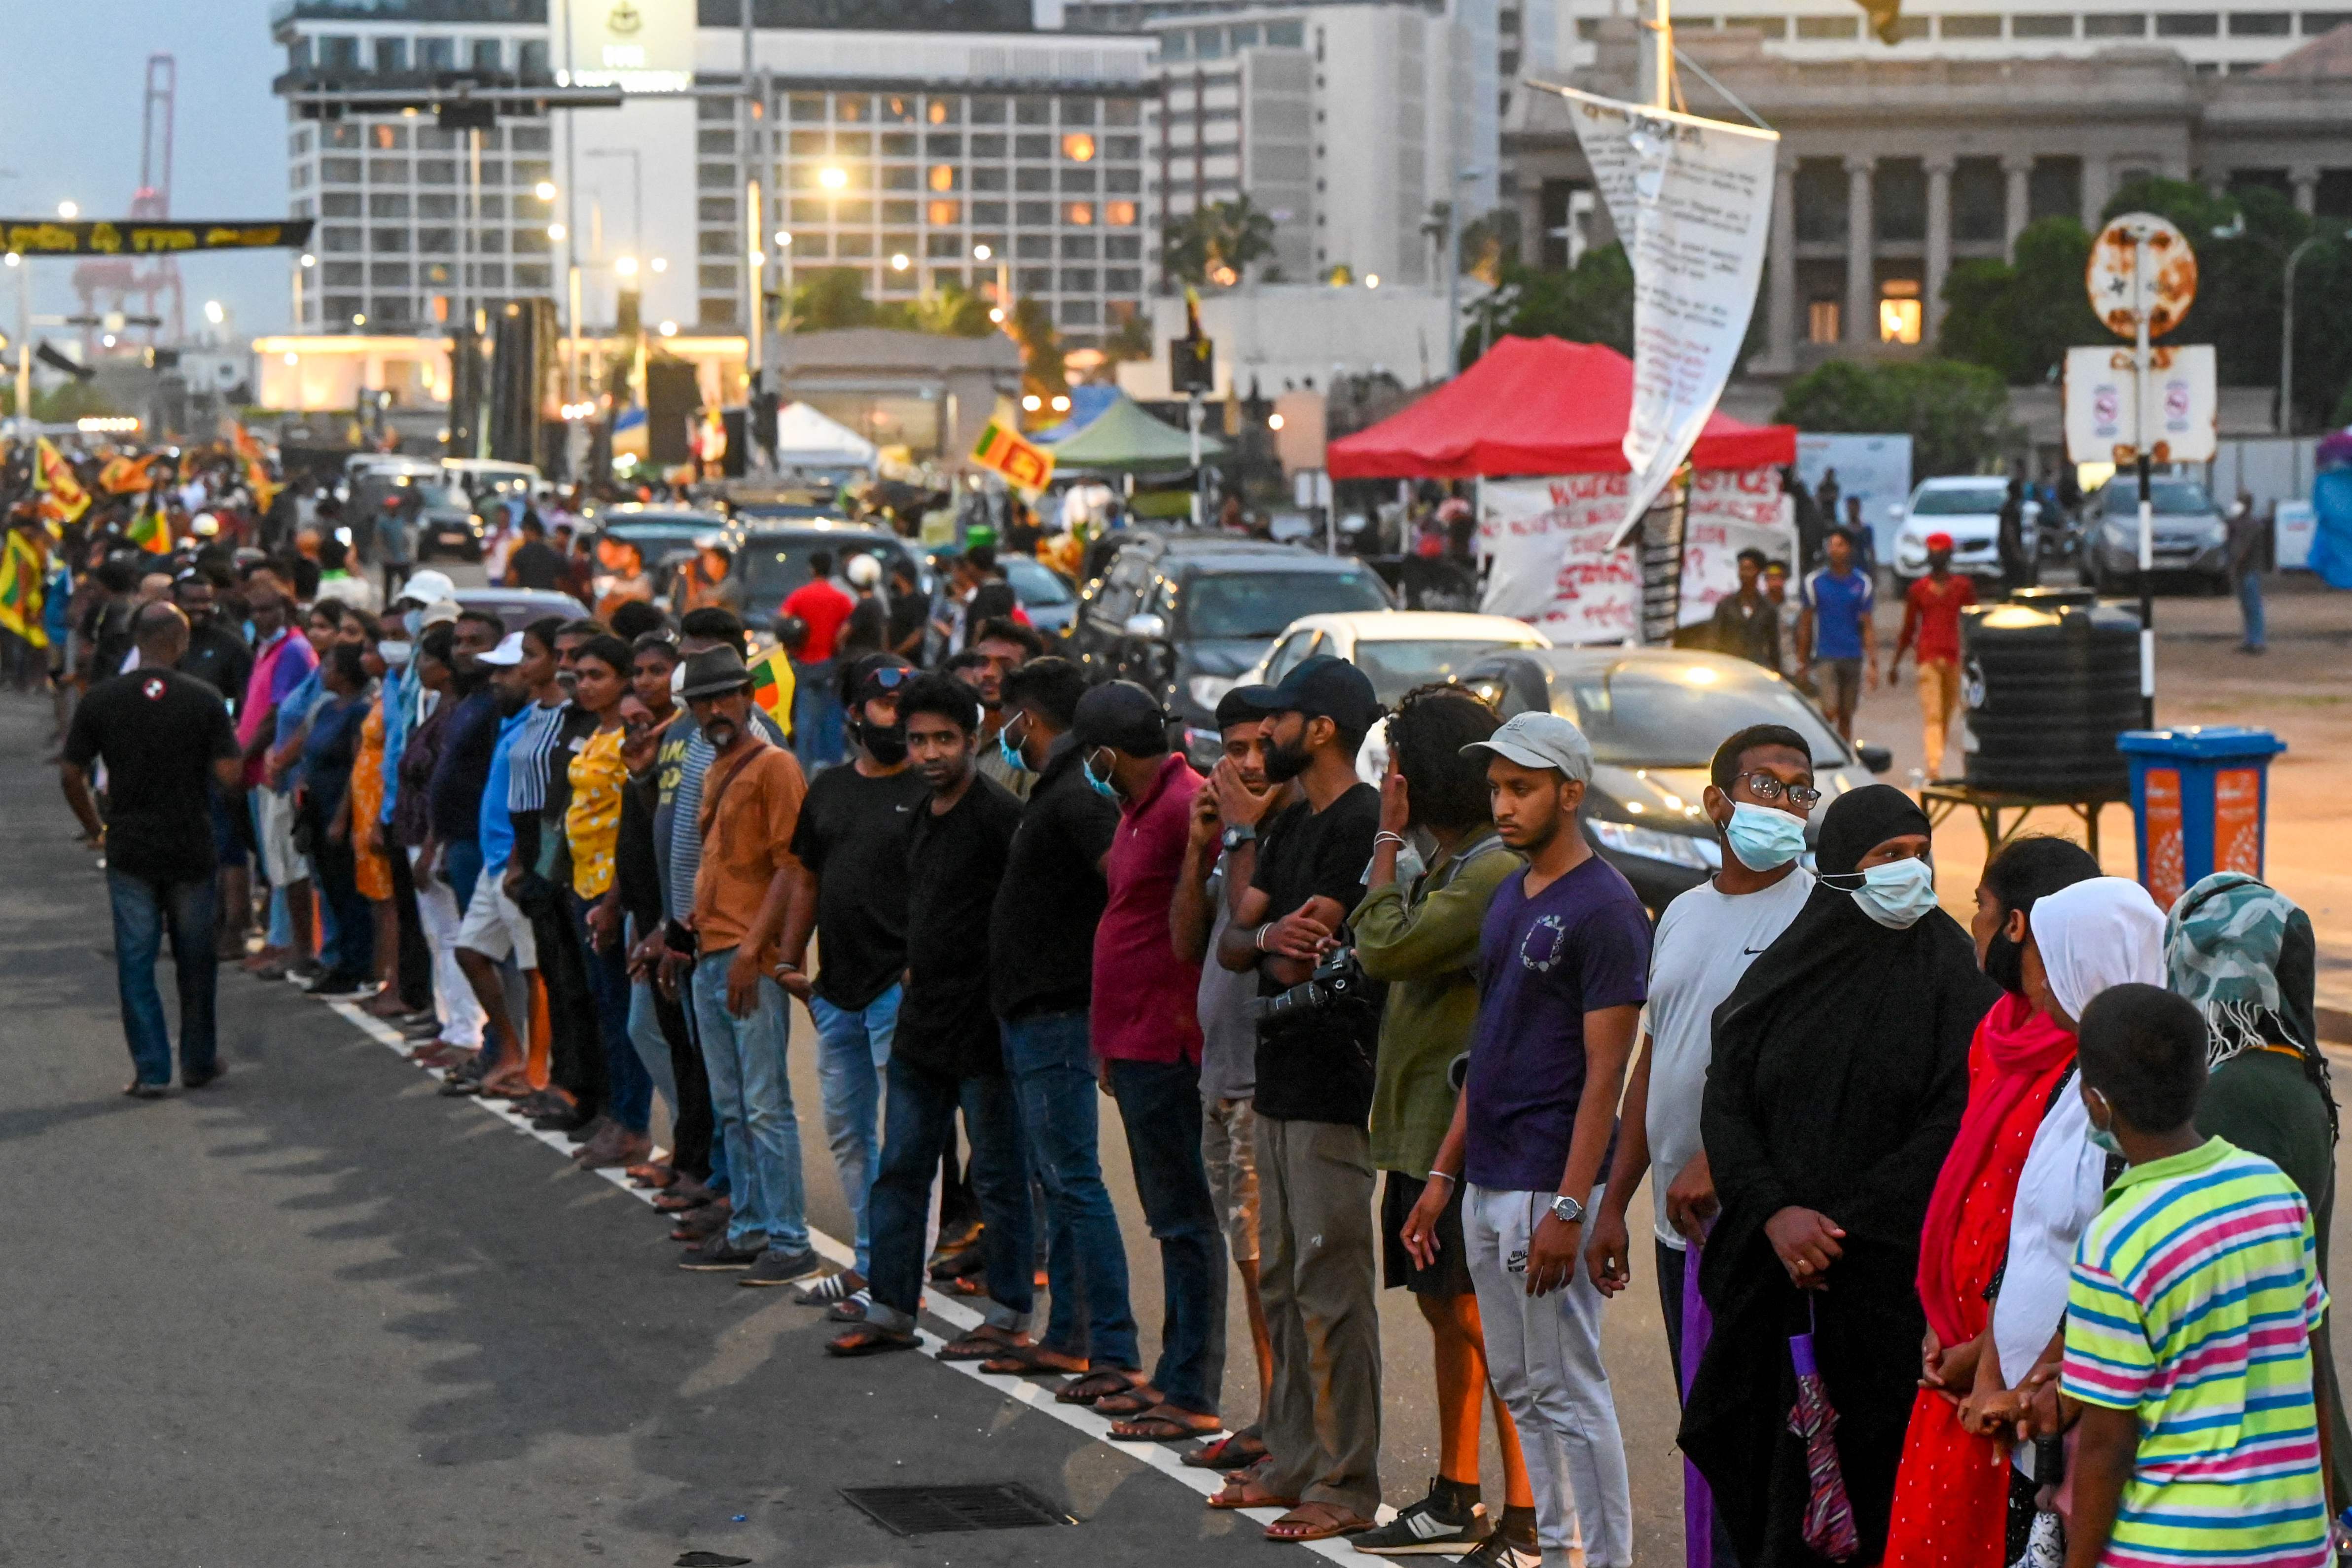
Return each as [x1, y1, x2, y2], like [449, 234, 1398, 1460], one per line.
[981, 658, 1140, 1413]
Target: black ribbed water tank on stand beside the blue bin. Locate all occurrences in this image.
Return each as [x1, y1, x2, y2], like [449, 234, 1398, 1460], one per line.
[1961, 588, 2140, 797]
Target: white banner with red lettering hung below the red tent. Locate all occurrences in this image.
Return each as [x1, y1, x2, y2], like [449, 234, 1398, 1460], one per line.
[1477, 468, 1797, 644]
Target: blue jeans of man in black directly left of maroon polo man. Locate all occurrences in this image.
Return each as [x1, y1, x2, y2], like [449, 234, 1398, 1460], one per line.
[1004, 1011, 1134, 1371]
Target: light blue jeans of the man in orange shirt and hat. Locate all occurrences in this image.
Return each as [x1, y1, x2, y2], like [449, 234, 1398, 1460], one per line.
[694, 947, 809, 1253]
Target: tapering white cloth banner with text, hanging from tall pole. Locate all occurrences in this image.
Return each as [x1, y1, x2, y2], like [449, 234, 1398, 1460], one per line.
[1531, 82, 1781, 543]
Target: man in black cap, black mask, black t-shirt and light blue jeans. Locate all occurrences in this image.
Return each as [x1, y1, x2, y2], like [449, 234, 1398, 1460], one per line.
[776, 653, 929, 1310]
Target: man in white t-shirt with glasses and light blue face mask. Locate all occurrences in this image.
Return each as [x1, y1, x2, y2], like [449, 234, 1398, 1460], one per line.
[1585, 724, 1820, 1390]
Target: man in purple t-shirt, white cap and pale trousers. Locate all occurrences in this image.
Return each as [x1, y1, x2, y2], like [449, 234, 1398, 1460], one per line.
[1404, 713, 1649, 1568]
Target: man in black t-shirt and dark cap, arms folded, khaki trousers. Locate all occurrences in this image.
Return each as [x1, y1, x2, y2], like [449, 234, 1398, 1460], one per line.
[1216, 656, 1381, 1540]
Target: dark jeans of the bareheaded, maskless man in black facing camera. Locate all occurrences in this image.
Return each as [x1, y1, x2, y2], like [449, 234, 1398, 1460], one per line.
[865, 1053, 1035, 1333]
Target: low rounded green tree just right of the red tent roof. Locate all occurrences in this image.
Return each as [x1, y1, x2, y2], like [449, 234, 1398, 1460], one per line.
[1774, 359, 2018, 480]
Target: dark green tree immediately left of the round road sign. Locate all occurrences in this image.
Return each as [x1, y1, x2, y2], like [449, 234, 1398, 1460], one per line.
[1936, 218, 2107, 386]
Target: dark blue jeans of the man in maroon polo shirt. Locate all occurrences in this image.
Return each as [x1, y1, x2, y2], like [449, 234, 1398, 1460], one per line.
[1108, 1063, 1225, 1415]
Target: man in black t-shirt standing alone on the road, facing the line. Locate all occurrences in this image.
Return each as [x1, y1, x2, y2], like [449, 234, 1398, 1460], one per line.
[59, 604, 242, 1100]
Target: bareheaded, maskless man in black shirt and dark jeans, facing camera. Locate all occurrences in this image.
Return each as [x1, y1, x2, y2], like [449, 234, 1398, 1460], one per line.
[828, 675, 1035, 1359]
